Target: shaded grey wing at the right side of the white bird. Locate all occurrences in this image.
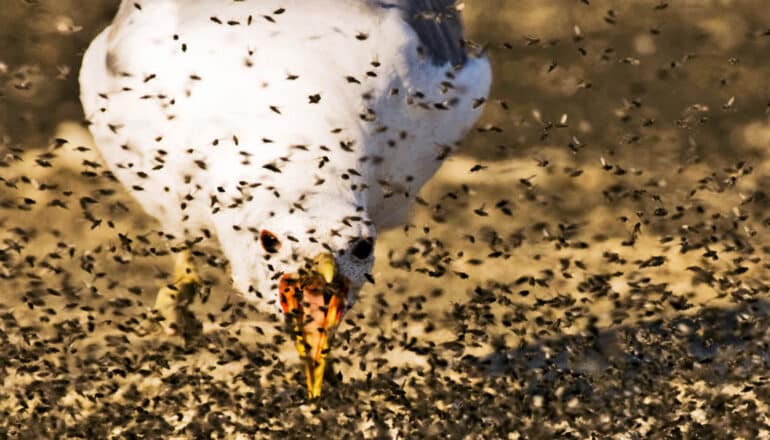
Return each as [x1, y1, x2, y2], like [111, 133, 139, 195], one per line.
[367, 0, 491, 230]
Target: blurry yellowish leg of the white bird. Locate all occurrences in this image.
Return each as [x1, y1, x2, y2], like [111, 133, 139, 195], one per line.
[153, 250, 201, 335]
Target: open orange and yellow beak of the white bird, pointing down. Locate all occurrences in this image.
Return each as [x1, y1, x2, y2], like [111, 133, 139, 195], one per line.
[279, 253, 350, 399]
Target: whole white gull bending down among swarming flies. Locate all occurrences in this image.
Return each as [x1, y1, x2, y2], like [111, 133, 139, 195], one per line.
[80, 0, 491, 397]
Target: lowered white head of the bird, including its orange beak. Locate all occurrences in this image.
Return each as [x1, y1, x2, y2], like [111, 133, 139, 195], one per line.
[220, 206, 375, 398]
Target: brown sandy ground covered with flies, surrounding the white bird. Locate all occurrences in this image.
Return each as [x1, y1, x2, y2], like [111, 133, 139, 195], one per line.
[0, 0, 770, 439]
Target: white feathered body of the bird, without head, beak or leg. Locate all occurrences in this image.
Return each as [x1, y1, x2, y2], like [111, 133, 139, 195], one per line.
[80, 0, 490, 308]
